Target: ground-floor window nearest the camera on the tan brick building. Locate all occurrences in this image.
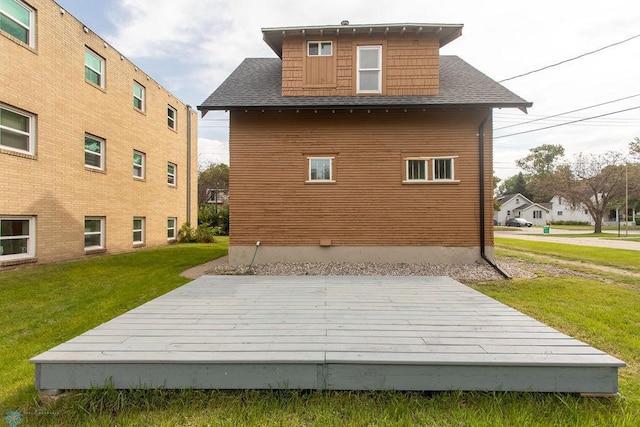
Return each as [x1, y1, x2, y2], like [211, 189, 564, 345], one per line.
[0, 217, 36, 262]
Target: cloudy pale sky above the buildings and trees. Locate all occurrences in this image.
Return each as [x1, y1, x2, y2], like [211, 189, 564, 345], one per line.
[57, 0, 640, 179]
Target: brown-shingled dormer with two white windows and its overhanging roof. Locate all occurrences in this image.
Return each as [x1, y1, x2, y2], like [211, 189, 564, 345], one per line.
[262, 21, 462, 97]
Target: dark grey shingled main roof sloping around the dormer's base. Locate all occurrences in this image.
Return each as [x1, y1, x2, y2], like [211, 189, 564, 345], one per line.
[198, 56, 532, 113]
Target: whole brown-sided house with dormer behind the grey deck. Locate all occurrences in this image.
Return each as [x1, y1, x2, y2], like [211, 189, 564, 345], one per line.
[198, 21, 531, 264]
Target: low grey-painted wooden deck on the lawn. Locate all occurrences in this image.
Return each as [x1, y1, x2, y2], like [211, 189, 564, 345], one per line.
[31, 276, 625, 394]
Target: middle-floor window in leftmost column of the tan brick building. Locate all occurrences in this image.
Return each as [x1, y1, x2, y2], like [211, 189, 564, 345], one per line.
[0, 104, 36, 154]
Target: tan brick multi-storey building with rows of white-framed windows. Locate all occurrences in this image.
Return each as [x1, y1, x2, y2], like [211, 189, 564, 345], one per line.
[0, 0, 197, 268]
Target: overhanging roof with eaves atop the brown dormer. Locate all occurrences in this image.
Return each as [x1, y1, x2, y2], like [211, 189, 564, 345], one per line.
[262, 23, 463, 58]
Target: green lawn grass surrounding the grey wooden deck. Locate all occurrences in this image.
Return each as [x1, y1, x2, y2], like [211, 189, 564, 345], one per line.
[0, 239, 640, 426]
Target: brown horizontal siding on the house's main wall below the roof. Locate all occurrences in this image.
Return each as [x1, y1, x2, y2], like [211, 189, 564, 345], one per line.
[230, 110, 493, 247]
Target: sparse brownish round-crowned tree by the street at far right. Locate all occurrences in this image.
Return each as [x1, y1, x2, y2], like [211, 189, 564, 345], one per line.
[553, 151, 625, 233]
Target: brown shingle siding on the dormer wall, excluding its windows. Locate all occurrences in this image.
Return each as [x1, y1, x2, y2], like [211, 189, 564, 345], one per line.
[282, 34, 439, 96]
